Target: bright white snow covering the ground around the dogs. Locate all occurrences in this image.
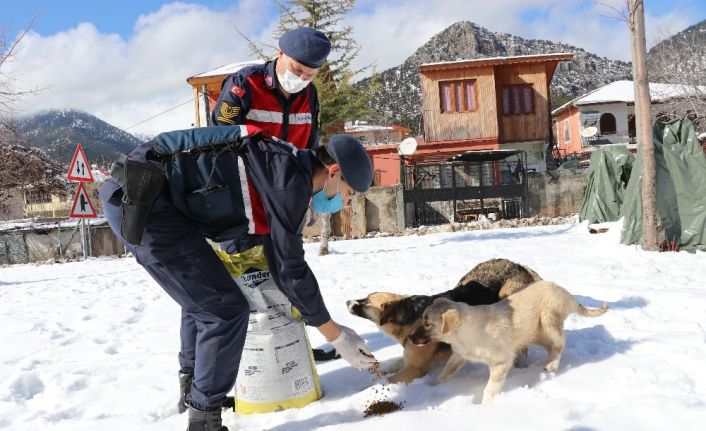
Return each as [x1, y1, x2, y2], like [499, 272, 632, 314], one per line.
[0, 224, 706, 431]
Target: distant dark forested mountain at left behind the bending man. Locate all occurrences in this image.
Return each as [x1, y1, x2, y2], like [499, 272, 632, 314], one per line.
[17, 110, 142, 164]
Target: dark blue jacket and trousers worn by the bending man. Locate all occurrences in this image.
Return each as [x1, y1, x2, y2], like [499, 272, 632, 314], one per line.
[100, 126, 330, 409]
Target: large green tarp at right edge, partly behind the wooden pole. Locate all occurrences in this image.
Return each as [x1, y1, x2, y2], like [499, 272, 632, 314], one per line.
[620, 119, 706, 251]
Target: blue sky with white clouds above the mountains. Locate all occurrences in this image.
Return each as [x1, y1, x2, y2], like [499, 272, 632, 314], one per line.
[0, 0, 706, 134]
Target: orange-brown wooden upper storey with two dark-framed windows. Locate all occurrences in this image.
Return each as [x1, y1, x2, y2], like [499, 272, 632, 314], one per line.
[420, 53, 573, 171]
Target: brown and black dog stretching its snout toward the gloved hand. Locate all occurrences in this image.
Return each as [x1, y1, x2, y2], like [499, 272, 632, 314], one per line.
[346, 259, 541, 384]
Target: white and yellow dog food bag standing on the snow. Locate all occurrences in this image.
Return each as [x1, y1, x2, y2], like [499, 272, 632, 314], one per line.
[216, 246, 322, 414]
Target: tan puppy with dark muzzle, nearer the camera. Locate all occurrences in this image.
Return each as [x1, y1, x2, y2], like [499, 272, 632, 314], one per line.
[409, 281, 608, 404]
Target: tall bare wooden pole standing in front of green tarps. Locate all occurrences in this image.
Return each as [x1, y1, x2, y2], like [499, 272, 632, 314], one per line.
[626, 0, 658, 251]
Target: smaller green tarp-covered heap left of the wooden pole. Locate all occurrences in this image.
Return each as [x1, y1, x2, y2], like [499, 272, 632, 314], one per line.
[579, 145, 635, 223]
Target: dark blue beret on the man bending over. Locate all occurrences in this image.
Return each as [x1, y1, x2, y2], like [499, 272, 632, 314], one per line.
[326, 135, 373, 193]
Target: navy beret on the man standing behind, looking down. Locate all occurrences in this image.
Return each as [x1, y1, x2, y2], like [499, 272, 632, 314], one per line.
[279, 27, 331, 69]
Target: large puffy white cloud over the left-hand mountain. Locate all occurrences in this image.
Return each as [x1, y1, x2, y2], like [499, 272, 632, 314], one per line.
[9, 0, 272, 134]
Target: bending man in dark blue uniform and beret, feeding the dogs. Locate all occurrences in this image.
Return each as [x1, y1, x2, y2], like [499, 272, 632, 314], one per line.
[100, 126, 376, 431]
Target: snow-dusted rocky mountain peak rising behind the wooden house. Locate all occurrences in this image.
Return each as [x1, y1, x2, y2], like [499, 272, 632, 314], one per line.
[360, 21, 632, 133]
